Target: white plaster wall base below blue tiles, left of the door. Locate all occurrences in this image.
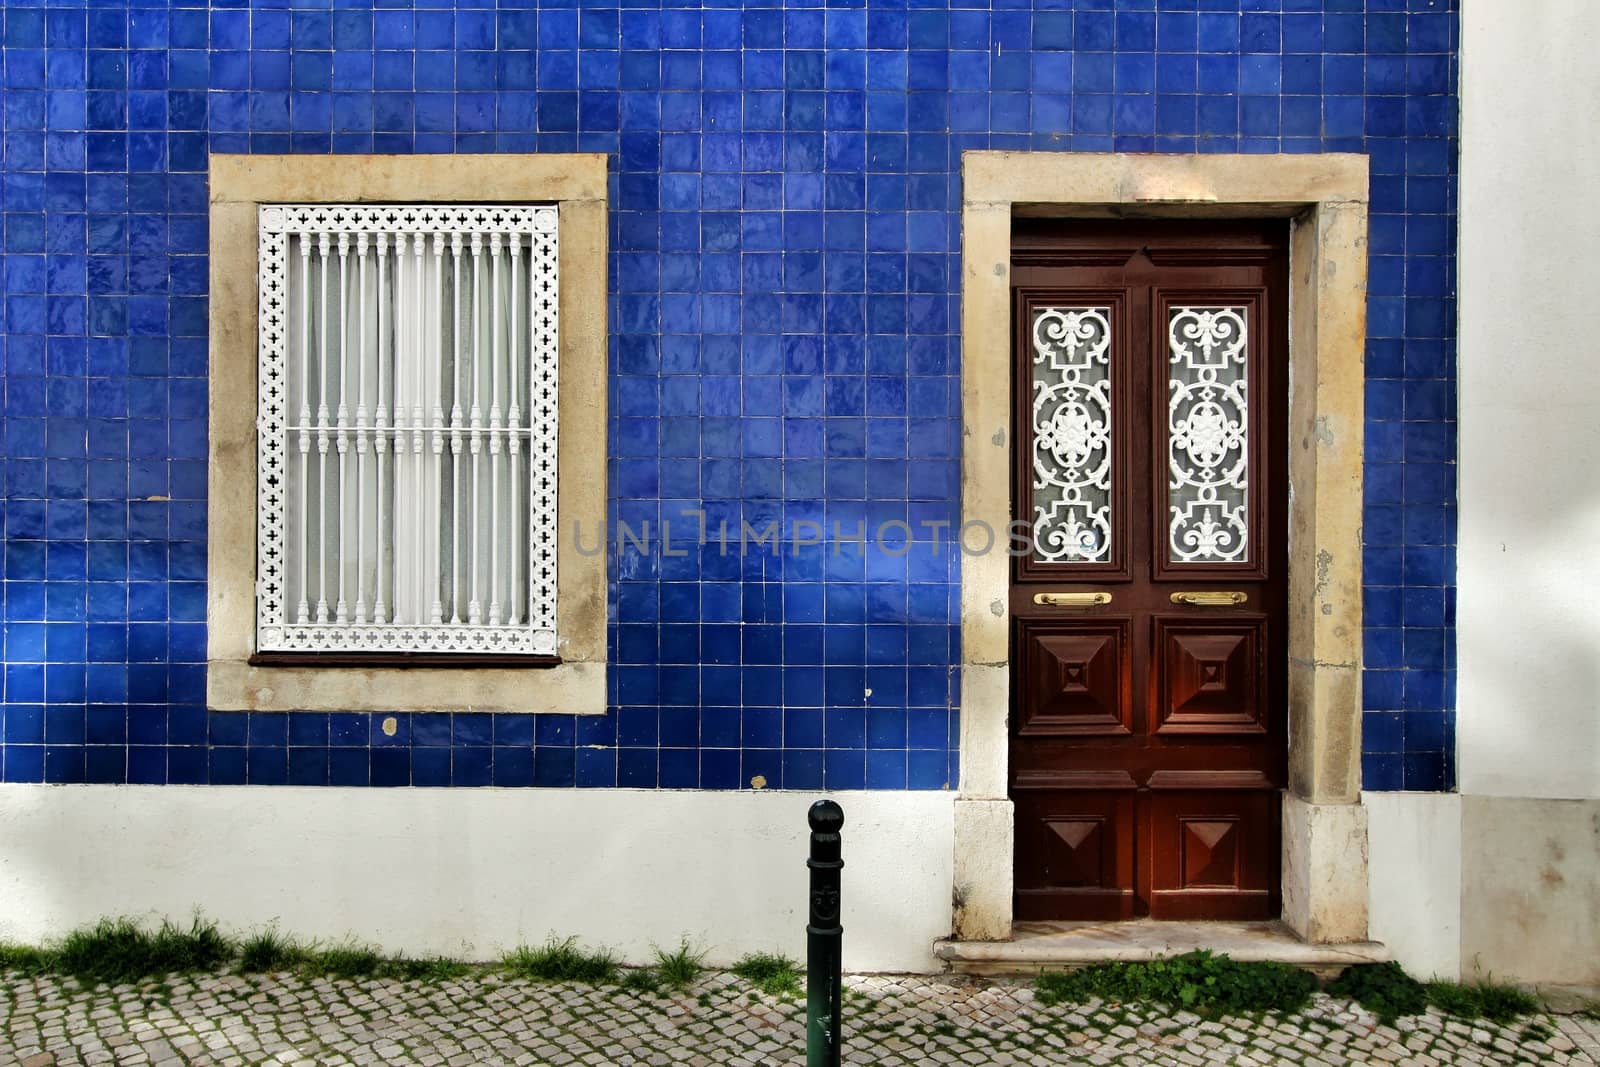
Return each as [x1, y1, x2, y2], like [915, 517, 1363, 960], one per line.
[0, 785, 954, 971]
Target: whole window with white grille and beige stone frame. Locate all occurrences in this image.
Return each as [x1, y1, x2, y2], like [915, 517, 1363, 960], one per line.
[206, 155, 606, 713]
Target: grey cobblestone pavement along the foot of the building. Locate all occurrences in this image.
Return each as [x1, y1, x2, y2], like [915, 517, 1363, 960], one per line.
[0, 971, 1600, 1067]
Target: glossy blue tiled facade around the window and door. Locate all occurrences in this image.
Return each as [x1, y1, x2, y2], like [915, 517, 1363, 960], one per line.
[0, 0, 1456, 790]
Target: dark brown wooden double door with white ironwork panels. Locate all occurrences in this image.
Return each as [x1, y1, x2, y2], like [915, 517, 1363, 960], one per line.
[1011, 221, 1288, 918]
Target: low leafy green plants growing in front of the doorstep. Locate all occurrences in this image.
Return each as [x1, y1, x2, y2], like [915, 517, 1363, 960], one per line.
[1034, 950, 1317, 1017]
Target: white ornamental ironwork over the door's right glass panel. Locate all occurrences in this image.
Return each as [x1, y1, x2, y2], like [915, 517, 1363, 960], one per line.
[1166, 307, 1250, 563]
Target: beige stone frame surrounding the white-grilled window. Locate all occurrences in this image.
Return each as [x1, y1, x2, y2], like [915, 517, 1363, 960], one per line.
[206, 152, 608, 715]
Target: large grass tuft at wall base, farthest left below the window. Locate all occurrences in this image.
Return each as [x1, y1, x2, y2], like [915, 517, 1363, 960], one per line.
[48, 917, 234, 984]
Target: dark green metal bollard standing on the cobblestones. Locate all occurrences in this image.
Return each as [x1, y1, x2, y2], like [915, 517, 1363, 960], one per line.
[805, 800, 845, 1067]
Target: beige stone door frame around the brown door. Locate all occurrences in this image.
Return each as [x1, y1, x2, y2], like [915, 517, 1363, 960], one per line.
[952, 150, 1368, 942]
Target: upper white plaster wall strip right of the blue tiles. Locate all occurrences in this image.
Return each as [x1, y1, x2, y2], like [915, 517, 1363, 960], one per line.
[1456, 0, 1600, 798]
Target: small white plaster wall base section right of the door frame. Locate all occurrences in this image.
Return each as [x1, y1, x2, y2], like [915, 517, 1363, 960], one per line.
[1362, 793, 1461, 979]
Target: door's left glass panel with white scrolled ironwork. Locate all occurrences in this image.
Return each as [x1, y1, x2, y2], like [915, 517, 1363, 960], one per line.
[1032, 307, 1112, 563]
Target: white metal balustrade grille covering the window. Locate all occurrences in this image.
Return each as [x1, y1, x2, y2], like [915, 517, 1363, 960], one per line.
[256, 203, 558, 654]
